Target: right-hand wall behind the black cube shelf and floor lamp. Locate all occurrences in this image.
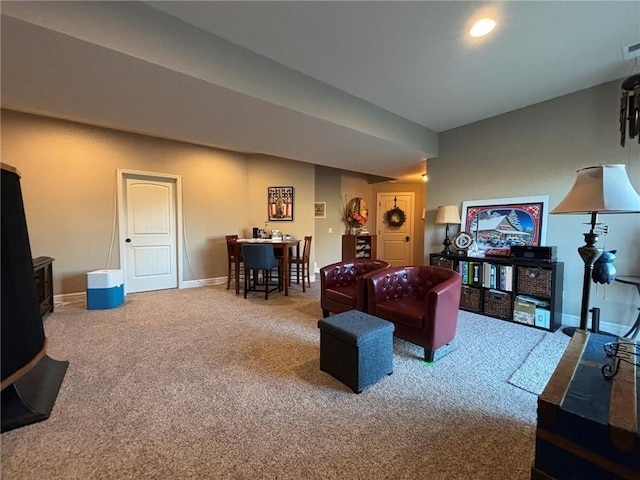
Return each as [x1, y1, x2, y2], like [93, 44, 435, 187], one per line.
[425, 81, 640, 333]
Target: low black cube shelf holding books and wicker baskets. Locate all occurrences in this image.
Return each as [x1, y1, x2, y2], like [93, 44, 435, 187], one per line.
[429, 253, 564, 332]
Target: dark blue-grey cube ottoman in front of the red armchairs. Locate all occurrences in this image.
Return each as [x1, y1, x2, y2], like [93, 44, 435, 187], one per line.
[318, 310, 395, 393]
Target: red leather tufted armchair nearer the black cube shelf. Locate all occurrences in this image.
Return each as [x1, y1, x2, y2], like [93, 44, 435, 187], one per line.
[366, 265, 462, 362]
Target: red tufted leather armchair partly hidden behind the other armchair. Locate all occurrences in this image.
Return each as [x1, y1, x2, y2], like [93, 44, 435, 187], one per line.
[320, 260, 389, 318]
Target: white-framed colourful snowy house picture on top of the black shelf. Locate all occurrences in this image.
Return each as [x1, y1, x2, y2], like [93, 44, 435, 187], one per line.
[462, 195, 549, 255]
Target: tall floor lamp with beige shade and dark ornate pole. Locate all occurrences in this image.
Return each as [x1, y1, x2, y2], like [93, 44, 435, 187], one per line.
[551, 165, 640, 336]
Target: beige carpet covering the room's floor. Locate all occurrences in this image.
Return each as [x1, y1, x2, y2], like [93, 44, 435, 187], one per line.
[1, 284, 564, 480]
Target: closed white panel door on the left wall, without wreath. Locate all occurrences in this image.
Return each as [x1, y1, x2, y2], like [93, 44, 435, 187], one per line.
[119, 173, 179, 293]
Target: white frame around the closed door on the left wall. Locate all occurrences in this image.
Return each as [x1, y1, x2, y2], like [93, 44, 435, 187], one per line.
[116, 168, 184, 293]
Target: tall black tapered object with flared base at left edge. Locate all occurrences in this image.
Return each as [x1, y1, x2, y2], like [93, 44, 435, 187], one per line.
[0, 164, 69, 432]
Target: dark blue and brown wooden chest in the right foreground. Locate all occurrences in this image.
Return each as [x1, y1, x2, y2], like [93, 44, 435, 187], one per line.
[531, 330, 640, 480]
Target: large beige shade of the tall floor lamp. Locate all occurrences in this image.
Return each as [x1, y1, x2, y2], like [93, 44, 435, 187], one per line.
[552, 165, 640, 214]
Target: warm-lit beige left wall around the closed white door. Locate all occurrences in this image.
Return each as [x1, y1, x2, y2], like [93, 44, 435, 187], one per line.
[1, 110, 315, 295]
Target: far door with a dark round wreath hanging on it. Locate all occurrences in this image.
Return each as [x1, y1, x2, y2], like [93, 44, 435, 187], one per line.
[376, 192, 415, 267]
